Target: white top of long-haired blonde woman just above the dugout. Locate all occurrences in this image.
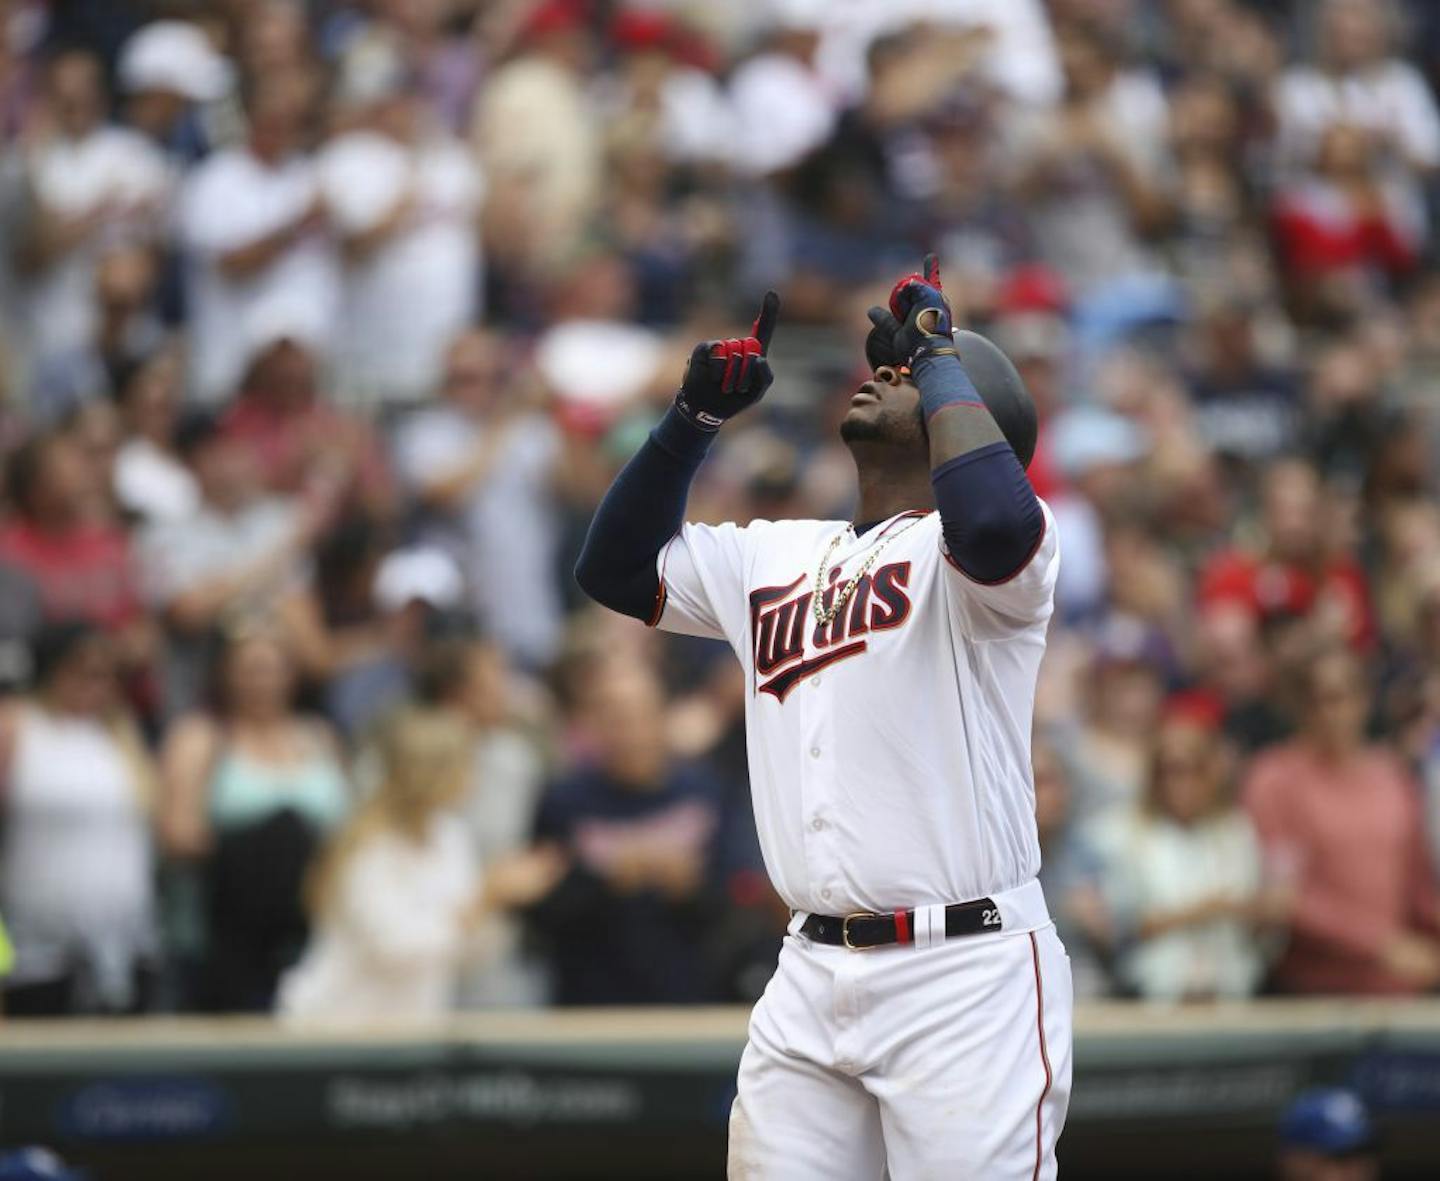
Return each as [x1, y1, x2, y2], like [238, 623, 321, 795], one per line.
[278, 814, 481, 1020]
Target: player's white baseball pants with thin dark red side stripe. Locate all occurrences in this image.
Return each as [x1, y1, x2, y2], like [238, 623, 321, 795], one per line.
[729, 883, 1073, 1181]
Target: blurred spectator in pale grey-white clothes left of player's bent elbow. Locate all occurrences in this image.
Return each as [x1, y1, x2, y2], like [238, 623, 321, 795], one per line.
[395, 331, 563, 668]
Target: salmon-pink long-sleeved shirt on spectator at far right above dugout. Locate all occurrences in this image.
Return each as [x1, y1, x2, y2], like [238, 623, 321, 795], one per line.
[1244, 742, 1440, 995]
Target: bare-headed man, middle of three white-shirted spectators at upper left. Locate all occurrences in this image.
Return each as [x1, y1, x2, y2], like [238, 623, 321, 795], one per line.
[179, 71, 338, 406]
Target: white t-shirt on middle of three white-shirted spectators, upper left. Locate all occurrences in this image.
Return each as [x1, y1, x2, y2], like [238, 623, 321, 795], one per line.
[179, 147, 340, 405]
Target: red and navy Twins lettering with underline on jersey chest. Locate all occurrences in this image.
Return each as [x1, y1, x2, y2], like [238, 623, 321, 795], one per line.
[750, 562, 910, 701]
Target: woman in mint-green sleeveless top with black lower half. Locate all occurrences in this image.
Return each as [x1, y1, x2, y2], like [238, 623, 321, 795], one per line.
[160, 631, 350, 1011]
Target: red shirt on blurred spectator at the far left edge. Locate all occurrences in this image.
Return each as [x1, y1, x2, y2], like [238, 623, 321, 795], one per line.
[0, 518, 141, 628]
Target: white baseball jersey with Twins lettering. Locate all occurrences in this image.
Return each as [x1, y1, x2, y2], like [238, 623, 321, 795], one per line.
[655, 506, 1060, 915]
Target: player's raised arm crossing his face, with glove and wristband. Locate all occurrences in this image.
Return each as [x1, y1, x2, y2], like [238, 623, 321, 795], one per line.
[870, 253, 1045, 583]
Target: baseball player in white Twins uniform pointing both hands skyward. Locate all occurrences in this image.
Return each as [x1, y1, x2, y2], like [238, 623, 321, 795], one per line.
[576, 255, 1071, 1181]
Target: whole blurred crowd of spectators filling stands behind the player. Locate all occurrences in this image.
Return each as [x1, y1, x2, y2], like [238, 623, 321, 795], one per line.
[0, 0, 1440, 1015]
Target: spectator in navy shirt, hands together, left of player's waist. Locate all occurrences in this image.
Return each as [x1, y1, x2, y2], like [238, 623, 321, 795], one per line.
[530, 665, 720, 1005]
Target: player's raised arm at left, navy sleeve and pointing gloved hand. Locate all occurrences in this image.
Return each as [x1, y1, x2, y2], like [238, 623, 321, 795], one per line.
[575, 291, 780, 624]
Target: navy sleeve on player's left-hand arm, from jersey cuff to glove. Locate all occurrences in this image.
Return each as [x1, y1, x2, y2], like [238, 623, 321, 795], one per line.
[575, 406, 716, 624]
